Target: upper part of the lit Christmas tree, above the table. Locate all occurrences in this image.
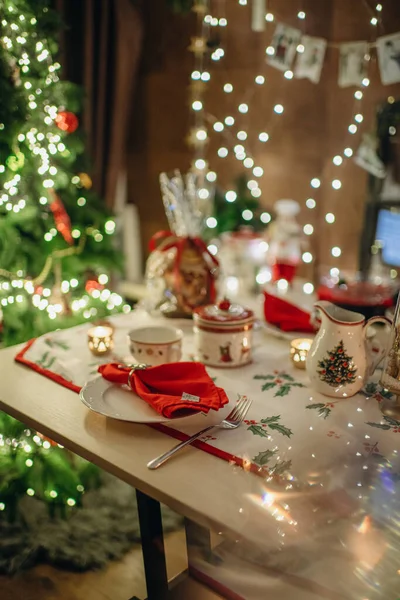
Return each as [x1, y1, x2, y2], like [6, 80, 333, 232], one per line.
[0, 0, 129, 345]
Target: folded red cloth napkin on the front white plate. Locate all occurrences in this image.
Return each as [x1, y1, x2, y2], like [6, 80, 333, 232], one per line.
[99, 362, 229, 419]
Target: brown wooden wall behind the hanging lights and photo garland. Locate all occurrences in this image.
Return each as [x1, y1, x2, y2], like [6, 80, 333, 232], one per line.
[129, 0, 400, 277]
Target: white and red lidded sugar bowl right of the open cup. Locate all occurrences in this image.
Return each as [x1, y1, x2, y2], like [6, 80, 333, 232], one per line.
[193, 298, 254, 367]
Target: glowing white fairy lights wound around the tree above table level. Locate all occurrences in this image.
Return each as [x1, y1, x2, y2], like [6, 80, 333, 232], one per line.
[0, 5, 130, 319]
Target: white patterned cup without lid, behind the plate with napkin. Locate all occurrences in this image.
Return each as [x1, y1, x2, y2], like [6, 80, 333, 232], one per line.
[128, 325, 183, 367]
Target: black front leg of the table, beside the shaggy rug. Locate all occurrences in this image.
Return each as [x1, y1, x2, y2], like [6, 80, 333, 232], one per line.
[132, 490, 168, 600]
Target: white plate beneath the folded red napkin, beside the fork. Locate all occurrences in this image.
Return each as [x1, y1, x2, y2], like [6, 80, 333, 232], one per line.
[79, 375, 238, 426]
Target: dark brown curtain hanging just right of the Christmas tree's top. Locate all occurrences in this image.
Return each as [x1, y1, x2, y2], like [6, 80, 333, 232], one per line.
[56, 0, 143, 208]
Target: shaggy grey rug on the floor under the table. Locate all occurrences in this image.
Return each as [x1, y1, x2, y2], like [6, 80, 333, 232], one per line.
[0, 473, 182, 574]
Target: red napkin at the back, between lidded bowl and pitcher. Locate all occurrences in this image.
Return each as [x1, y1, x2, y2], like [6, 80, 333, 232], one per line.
[264, 292, 315, 333]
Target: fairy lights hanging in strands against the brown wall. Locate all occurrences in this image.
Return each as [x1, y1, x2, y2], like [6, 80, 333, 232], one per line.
[191, 0, 383, 294]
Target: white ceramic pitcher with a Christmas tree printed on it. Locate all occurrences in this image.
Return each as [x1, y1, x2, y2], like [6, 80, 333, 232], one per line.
[307, 300, 391, 398]
